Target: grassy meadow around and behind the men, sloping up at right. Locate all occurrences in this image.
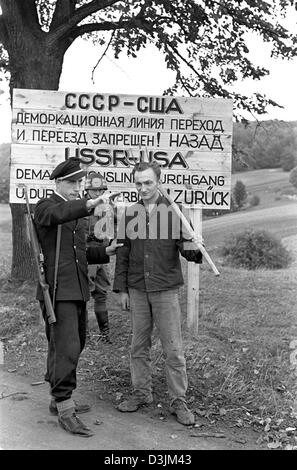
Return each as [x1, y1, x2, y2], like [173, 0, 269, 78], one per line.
[0, 170, 297, 449]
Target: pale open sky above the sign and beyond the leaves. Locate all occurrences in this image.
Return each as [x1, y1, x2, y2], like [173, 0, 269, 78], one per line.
[0, 24, 297, 143]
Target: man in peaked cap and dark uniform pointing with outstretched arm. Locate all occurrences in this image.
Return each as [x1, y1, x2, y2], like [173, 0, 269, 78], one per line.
[34, 158, 120, 437]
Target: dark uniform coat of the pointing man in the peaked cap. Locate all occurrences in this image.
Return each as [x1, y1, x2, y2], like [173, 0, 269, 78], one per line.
[34, 193, 109, 302]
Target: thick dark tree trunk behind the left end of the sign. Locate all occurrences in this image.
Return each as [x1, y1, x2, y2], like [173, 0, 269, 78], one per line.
[5, 13, 67, 280]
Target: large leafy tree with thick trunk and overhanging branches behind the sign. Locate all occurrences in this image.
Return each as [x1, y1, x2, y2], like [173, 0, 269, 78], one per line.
[0, 0, 296, 279]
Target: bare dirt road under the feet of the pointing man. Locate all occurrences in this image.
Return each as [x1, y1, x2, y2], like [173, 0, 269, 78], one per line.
[0, 366, 257, 452]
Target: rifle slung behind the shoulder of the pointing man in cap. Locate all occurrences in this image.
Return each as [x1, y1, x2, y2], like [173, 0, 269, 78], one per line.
[24, 185, 56, 324]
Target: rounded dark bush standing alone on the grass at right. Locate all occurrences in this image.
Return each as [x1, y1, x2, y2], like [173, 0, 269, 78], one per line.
[222, 229, 291, 269]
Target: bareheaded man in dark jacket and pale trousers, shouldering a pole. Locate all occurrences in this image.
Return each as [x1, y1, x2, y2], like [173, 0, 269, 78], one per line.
[113, 162, 202, 425]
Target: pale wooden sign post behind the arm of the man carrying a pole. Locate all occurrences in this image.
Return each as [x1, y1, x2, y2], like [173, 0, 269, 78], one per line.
[187, 207, 202, 334]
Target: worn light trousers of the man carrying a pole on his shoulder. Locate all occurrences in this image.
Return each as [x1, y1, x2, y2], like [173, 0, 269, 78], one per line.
[129, 288, 188, 402]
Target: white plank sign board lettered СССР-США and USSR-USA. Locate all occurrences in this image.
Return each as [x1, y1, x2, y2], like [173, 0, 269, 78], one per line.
[10, 89, 233, 209]
